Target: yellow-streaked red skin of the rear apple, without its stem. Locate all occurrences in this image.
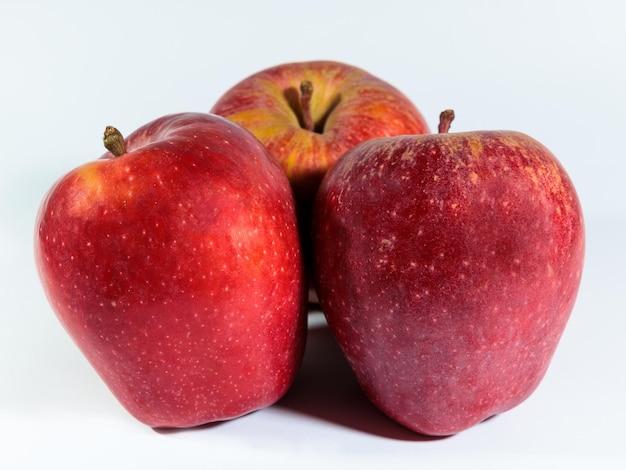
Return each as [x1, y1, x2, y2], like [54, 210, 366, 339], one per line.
[211, 60, 429, 212]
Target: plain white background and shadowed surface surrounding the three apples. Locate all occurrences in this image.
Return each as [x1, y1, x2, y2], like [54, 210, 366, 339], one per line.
[0, 0, 626, 469]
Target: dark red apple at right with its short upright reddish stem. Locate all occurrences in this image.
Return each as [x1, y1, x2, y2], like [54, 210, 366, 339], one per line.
[313, 111, 585, 436]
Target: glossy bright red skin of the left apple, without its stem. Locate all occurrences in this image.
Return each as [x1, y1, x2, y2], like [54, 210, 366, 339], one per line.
[35, 113, 306, 428]
